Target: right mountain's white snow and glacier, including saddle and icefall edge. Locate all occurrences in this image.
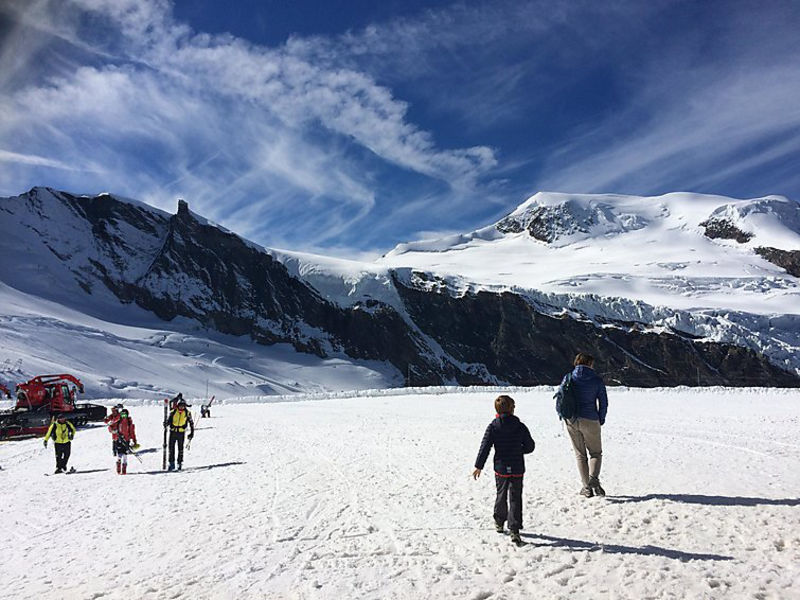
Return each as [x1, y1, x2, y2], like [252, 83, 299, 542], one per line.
[271, 193, 800, 380]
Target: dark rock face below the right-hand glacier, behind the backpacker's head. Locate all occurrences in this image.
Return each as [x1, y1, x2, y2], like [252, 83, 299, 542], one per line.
[395, 274, 800, 387]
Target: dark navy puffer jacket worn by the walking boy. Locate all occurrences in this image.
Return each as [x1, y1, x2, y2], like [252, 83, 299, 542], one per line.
[475, 415, 536, 475]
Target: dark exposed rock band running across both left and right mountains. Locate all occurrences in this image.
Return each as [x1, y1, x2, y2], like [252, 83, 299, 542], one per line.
[6, 189, 800, 386]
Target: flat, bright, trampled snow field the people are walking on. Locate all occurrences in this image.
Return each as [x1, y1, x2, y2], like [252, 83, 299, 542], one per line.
[0, 388, 800, 600]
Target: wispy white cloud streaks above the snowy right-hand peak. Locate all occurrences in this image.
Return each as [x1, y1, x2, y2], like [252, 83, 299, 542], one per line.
[539, 58, 800, 194]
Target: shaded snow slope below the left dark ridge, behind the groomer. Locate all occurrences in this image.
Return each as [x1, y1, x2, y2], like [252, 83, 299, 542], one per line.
[0, 284, 402, 398]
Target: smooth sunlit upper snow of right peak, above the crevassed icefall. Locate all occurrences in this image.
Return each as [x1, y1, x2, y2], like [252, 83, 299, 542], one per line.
[379, 193, 800, 314]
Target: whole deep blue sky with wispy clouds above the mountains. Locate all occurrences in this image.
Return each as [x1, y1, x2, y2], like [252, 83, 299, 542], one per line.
[0, 0, 800, 257]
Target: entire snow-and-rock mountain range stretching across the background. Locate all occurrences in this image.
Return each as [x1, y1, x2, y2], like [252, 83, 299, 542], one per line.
[0, 188, 800, 395]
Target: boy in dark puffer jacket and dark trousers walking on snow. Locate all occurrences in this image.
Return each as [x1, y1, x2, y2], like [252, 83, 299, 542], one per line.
[472, 395, 535, 544]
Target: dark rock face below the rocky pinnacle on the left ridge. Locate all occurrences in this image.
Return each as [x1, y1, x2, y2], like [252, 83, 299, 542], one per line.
[72, 199, 433, 377]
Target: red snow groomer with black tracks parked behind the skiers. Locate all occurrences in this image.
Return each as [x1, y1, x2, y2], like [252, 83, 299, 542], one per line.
[0, 374, 106, 439]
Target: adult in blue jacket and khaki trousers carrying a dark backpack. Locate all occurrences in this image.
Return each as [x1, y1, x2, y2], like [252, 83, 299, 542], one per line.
[561, 352, 608, 498]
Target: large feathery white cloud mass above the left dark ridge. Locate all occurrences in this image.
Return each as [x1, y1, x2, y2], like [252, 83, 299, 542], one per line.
[0, 0, 496, 251]
